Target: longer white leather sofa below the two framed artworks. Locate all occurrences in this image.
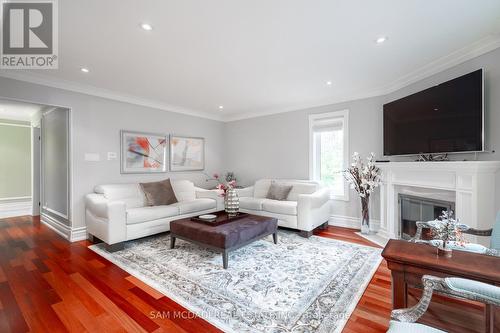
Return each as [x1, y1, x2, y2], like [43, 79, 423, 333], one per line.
[85, 179, 224, 251]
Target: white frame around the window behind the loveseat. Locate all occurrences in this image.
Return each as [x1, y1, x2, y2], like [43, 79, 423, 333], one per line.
[309, 109, 350, 201]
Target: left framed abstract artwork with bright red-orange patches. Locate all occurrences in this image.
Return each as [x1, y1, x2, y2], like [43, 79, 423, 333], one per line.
[120, 131, 168, 173]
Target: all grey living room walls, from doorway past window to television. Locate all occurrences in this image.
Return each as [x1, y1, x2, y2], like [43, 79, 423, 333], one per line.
[0, 45, 500, 227]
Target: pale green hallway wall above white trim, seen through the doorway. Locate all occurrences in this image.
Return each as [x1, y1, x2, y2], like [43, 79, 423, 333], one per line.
[0, 120, 31, 199]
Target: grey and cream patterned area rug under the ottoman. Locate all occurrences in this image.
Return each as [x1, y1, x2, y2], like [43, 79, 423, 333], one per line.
[90, 231, 381, 333]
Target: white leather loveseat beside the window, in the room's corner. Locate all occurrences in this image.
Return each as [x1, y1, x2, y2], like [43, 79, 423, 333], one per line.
[237, 179, 331, 237]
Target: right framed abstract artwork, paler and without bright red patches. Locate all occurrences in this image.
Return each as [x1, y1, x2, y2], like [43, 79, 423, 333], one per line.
[170, 135, 205, 171]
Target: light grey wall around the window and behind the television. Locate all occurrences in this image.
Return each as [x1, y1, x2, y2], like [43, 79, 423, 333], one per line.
[226, 49, 500, 219]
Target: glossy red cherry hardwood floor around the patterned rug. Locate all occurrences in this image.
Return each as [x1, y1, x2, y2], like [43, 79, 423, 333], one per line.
[0, 216, 483, 333]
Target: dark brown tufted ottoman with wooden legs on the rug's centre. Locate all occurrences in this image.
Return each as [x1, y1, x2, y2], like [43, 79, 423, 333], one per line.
[170, 212, 278, 269]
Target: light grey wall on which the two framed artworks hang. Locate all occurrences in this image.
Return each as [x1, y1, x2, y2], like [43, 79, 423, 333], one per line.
[0, 77, 226, 227]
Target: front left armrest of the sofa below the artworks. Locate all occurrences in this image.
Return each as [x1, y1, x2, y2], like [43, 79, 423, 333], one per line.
[85, 193, 127, 245]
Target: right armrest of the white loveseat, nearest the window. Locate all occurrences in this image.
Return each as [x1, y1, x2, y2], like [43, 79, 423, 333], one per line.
[297, 188, 331, 231]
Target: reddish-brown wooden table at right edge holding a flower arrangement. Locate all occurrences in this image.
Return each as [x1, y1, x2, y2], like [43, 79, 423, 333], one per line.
[382, 239, 500, 332]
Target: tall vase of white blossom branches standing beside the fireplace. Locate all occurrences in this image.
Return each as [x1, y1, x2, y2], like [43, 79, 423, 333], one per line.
[343, 152, 381, 234]
